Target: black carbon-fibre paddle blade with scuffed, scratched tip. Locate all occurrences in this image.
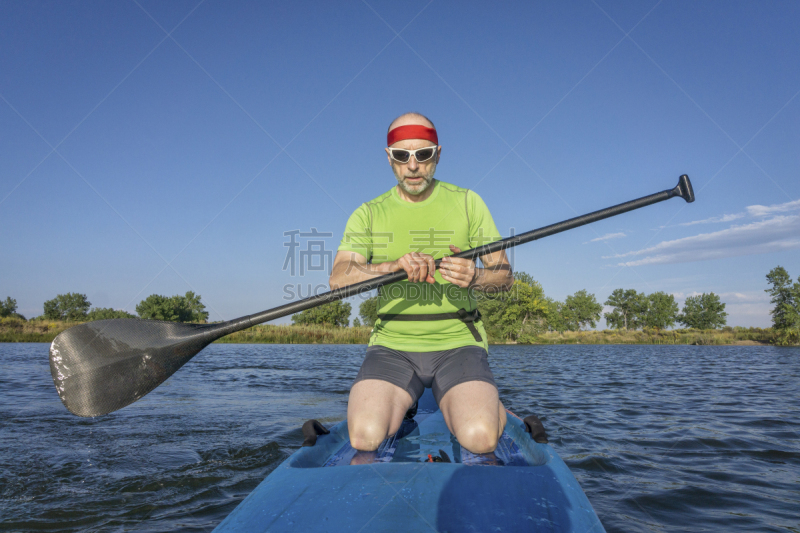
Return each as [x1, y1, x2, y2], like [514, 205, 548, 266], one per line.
[50, 318, 217, 416]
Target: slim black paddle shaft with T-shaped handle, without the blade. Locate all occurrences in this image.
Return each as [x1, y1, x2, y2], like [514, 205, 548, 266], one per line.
[214, 174, 694, 337]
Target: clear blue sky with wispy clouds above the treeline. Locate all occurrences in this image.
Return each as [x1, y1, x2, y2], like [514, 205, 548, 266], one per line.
[0, 0, 800, 326]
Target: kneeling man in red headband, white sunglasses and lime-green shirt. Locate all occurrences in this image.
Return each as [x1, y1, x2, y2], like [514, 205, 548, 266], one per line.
[330, 113, 514, 453]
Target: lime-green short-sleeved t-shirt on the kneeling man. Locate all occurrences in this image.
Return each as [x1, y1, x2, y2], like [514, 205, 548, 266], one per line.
[339, 180, 501, 352]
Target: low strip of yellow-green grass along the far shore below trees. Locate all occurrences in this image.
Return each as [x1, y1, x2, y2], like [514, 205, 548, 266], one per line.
[0, 317, 777, 346]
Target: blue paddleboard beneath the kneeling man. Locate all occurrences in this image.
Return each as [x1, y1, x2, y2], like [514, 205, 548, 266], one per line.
[215, 389, 605, 533]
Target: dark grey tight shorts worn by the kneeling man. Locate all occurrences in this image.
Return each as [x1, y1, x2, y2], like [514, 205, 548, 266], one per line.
[353, 345, 497, 403]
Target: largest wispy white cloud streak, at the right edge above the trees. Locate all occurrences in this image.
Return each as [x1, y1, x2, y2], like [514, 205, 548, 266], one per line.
[606, 214, 800, 266]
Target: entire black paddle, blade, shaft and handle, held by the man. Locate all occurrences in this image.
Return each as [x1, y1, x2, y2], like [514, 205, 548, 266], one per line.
[50, 174, 694, 416]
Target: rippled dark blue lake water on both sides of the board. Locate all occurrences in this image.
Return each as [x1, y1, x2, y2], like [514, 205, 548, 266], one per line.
[0, 344, 800, 532]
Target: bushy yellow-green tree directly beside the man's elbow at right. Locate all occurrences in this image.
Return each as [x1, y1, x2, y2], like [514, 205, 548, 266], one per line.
[478, 272, 551, 341]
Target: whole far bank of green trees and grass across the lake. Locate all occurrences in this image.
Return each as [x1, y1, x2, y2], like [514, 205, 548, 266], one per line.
[0, 266, 800, 345]
